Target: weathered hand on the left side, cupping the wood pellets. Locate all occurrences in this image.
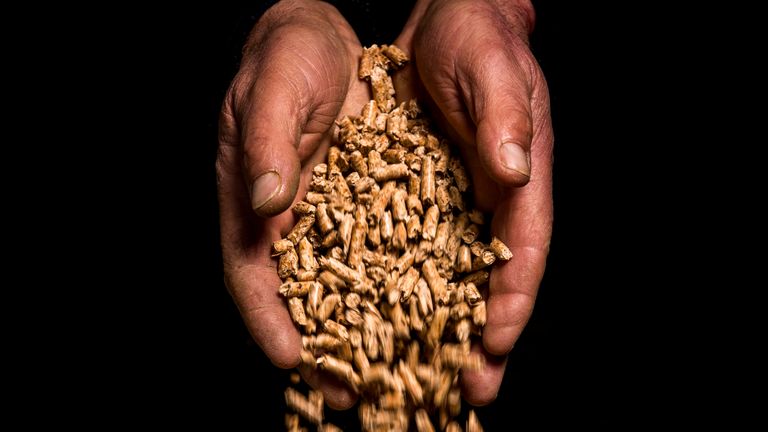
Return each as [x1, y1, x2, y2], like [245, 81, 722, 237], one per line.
[216, 1, 370, 409]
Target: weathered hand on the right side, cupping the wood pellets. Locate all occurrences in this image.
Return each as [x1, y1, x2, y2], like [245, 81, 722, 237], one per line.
[394, 0, 553, 405]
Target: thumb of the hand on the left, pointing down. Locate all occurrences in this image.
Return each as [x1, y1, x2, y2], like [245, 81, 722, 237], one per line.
[240, 72, 308, 217]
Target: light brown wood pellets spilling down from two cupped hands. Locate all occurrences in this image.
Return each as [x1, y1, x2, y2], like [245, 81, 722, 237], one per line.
[273, 45, 512, 432]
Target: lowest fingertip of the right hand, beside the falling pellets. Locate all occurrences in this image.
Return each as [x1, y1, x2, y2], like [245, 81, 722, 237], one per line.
[461, 344, 507, 406]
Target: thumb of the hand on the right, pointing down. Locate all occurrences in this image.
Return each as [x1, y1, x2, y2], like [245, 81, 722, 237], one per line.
[458, 47, 533, 186]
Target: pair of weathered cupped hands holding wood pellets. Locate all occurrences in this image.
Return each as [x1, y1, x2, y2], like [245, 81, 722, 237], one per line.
[217, 0, 553, 409]
